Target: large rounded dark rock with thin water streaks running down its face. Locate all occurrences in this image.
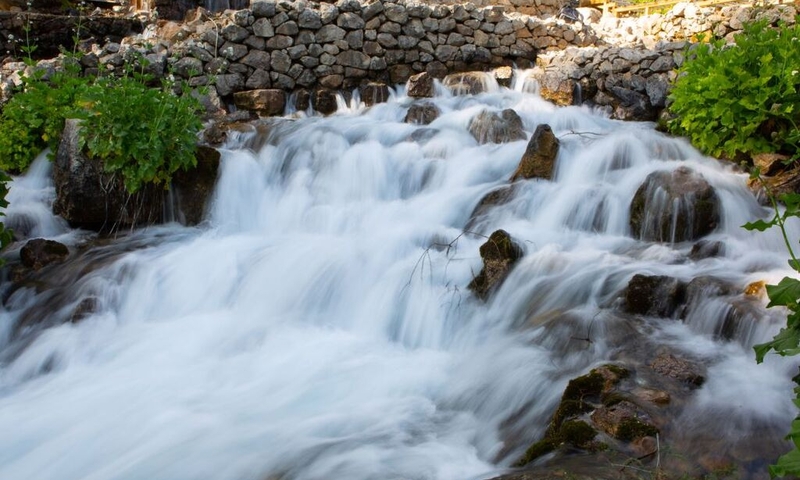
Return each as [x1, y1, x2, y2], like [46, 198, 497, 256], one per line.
[630, 166, 720, 242]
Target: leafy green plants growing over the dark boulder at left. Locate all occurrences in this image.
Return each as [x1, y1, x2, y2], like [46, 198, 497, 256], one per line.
[0, 57, 202, 193]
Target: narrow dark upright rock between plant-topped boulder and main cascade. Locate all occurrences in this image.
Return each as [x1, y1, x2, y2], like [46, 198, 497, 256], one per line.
[172, 145, 220, 225]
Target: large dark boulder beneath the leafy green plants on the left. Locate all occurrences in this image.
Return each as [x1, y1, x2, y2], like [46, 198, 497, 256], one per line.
[53, 119, 164, 231]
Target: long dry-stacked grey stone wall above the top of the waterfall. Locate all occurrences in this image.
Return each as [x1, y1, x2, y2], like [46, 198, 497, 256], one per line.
[159, 0, 594, 96]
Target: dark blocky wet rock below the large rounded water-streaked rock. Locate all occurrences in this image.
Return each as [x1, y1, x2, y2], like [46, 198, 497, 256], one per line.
[624, 274, 686, 317]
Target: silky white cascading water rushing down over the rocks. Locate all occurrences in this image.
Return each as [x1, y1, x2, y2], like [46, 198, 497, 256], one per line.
[0, 79, 800, 480]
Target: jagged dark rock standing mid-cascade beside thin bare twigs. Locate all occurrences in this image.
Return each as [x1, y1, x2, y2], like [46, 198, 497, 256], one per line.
[469, 230, 522, 300]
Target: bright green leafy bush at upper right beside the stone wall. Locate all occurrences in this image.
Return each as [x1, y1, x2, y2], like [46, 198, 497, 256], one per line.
[669, 17, 800, 163]
